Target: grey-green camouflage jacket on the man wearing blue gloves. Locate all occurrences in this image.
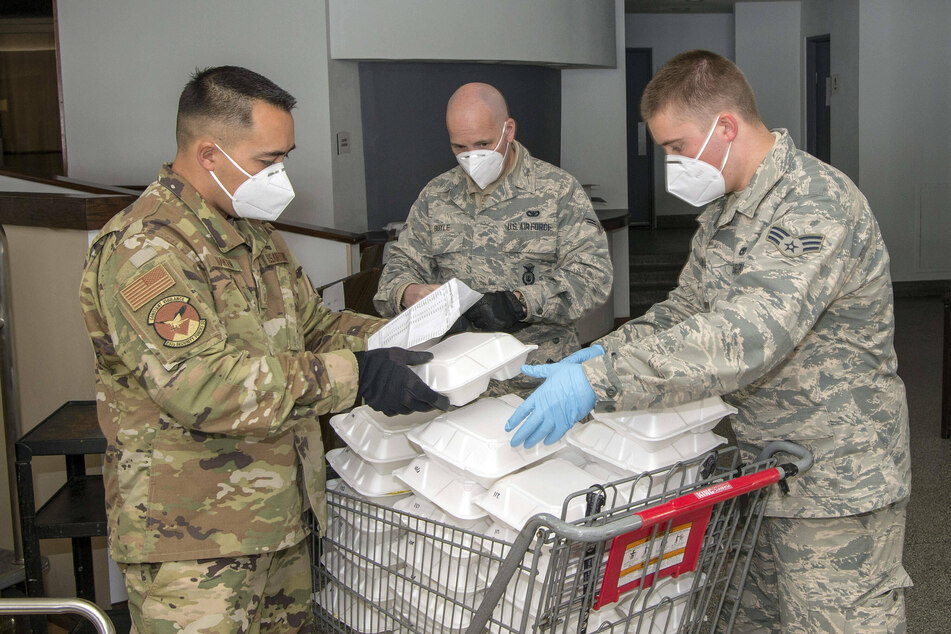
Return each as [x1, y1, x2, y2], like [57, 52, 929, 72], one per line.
[584, 130, 911, 517]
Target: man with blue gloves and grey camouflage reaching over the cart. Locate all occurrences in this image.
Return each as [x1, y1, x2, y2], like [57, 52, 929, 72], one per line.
[512, 51, 911, 633]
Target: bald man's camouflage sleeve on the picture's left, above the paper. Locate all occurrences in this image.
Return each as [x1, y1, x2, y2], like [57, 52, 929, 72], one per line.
[373, 189, 438, 317]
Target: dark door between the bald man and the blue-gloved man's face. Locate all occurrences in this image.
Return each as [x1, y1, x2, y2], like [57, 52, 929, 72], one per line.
[625, 48, 654, 228]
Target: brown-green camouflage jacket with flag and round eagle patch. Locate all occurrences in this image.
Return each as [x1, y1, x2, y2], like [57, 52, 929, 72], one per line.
[80, 166, 382, 563]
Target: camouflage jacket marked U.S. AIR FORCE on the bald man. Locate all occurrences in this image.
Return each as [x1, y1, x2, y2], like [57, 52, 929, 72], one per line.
[373, 143, 613, 362]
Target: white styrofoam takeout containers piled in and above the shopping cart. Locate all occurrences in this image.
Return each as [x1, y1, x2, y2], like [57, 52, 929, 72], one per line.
[318, 326, 735, 634]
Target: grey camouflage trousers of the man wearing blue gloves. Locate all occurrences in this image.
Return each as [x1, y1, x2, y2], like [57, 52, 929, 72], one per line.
[733, 500, 912, 634]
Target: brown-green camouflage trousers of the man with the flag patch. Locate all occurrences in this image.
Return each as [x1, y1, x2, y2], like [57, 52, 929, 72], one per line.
[123, 539, 316, 634]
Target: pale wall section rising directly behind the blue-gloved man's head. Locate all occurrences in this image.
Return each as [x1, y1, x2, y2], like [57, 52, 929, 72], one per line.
[734, 1, 804, 148]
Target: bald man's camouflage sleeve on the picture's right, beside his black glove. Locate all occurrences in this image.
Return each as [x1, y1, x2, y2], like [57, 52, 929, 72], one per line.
[511, 178, 614, 324]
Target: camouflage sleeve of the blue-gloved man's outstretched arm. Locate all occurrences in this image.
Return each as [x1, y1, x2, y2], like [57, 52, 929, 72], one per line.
[584, 201, 861, 410]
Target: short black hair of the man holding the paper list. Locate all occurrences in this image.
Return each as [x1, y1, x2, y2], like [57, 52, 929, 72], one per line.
[175, 66, 297, 147]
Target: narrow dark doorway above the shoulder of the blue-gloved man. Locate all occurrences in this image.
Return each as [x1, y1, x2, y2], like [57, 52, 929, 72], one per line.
[806, 35, 837, 163]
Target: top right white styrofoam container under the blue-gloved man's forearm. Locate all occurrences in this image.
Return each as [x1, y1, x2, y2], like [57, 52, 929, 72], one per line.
[591, 396, 736, 449]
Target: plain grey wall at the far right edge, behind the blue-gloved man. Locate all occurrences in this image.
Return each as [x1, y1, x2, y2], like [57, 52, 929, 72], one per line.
[858, 0, 951, 281]
